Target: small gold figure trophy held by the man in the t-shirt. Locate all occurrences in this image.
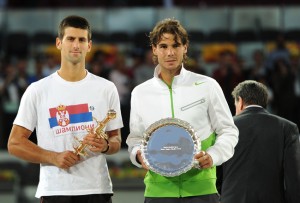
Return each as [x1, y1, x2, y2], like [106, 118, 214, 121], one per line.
[74, 109, 117, 156]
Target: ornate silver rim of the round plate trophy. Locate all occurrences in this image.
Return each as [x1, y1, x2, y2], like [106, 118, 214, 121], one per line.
[141, 118, 200, 177]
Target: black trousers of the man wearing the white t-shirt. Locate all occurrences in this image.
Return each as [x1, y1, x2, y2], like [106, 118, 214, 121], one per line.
[40, 194, 112, 203]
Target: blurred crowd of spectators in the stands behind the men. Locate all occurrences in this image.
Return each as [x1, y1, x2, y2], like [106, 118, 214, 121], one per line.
[0, 34, 300, 149]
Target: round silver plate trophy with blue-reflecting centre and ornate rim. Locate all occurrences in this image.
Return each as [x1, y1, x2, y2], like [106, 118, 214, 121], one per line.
[141, 118, 200, 177]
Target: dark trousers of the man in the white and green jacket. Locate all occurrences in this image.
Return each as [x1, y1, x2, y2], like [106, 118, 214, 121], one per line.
[144, 194, 220, 203]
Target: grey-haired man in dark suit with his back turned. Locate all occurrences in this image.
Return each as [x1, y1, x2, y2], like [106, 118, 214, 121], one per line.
[221, 80, 300, 203]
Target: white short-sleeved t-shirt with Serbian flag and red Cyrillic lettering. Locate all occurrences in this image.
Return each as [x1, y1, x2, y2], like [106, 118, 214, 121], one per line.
[14, 72, 123, 198]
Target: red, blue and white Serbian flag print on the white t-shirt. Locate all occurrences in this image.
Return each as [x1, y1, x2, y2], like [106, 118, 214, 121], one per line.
[49, 104, 93, 128]
